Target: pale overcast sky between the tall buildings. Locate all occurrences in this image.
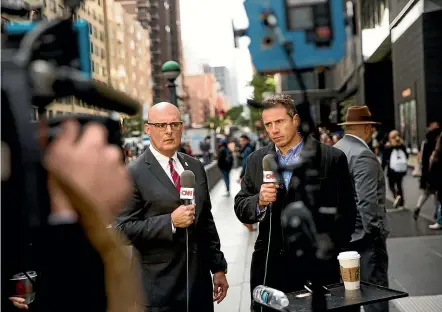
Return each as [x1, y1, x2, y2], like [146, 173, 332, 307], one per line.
[180, 0, 253, 103]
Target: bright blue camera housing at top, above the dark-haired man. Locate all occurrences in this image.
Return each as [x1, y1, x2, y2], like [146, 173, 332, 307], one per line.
[244, 0, 346, 74]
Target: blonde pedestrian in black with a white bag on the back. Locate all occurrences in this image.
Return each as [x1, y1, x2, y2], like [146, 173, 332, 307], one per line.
[382, 130, 408, 208]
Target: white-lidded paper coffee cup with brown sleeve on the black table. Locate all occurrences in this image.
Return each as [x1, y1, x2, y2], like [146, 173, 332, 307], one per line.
[338, 251, 361, 290]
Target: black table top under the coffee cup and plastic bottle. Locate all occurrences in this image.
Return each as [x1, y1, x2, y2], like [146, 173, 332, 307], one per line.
[258, 281, 408, 312]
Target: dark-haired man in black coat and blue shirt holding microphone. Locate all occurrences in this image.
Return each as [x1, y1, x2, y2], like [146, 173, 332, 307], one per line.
[235, 95, 356, 311]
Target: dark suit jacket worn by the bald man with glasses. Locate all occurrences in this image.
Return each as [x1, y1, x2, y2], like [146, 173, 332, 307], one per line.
[117, 149, 227, 311]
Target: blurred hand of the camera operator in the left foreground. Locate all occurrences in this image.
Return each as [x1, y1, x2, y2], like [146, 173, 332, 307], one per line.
[44, 121, 132, 221]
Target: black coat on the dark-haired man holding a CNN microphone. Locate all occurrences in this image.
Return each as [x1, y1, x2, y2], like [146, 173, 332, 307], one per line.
[235, 141, 356, 298]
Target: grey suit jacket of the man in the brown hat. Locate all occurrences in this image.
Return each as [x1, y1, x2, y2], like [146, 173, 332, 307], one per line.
[335, 135, 389, 242]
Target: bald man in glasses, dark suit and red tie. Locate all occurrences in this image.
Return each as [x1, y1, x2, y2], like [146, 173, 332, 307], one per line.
[117, 102, 228, 312]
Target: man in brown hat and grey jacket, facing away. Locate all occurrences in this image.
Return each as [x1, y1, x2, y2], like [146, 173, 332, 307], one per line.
[335, 106, 389, 312]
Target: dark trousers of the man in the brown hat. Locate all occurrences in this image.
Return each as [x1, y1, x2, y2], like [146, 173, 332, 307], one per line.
[354, 237, 389, 312]
